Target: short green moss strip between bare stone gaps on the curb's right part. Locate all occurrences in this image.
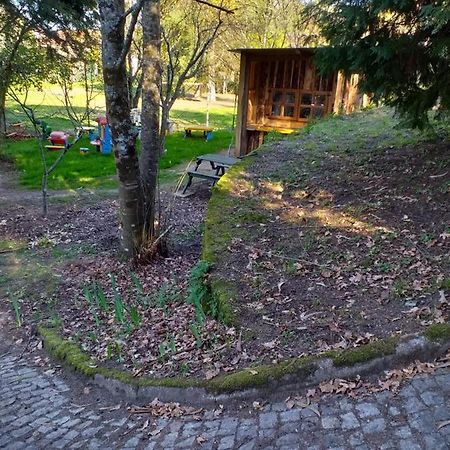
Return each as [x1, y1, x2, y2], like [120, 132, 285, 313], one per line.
[324, 337, 398, 367]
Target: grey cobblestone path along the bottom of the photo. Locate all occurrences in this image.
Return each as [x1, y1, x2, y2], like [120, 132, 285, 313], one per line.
[0, 355, 450, 450]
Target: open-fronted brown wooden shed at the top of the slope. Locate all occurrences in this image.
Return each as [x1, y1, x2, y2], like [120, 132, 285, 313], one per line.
[234, 48, 363, 156]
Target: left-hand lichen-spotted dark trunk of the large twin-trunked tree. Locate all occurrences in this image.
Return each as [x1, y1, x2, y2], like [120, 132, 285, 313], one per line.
[98, 0, 144, 256]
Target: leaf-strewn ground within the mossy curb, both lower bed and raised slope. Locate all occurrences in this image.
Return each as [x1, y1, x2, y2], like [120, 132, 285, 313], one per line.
[0, 107, 450, 382]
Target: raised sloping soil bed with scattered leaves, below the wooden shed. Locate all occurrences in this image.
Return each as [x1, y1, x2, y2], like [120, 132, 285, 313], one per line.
[208, 110, 450, 362]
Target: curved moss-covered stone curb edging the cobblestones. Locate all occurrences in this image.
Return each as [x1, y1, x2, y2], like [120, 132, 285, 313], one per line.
[38, 323, 450, 405]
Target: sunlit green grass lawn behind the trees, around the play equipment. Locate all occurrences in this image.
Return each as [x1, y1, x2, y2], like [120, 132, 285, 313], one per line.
[0, 85, 234, 190]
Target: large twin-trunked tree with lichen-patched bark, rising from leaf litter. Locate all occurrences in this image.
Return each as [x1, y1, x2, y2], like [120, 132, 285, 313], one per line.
[98, 0, 234, 256]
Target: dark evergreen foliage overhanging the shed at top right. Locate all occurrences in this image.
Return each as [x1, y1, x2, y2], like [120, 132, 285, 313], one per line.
[310, 0, 450, 127]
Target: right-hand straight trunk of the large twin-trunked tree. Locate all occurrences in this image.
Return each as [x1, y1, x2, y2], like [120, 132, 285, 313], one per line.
[140, 0, 161, 238]
